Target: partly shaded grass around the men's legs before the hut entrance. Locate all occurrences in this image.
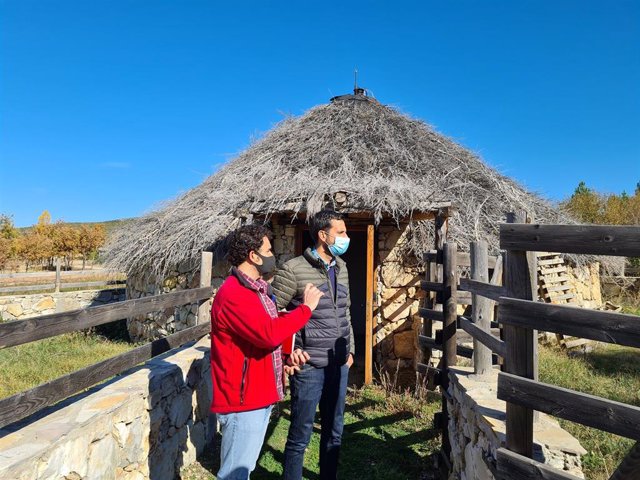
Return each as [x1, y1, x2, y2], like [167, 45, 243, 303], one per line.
[182, 386, 440, 480]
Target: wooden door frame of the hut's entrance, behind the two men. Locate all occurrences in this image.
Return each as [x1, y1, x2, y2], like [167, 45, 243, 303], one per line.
[294, 223, 377, 385]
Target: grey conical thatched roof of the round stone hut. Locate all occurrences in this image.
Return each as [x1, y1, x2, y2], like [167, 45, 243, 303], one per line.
[107, 91, 616, 275]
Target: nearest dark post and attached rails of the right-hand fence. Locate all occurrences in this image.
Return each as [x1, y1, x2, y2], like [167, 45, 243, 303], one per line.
[498, 223, 640, 480]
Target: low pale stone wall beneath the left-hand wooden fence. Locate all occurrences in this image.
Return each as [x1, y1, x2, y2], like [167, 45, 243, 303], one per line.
[0, 337, 216, 480]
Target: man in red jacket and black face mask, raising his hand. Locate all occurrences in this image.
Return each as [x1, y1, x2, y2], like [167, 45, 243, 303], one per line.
[211, 225, 323, 480]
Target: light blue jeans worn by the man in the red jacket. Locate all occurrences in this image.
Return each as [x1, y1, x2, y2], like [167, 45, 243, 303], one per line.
[217, 405, 273, 480]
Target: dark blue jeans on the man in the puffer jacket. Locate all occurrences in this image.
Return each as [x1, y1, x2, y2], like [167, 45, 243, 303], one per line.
[283, 364, 349, 480]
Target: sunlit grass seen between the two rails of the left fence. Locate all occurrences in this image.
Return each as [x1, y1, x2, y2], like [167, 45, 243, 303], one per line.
[0, 332, 135, 398]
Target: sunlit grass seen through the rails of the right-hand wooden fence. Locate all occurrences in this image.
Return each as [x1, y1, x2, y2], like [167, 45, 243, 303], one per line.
[539, 344, 640, 480]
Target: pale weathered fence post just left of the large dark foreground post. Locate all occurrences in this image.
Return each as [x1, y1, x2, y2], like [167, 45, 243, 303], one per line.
[471, 241, 492, 375]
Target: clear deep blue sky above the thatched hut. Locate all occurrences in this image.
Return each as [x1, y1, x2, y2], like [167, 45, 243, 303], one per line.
[0, 0, 640, 226]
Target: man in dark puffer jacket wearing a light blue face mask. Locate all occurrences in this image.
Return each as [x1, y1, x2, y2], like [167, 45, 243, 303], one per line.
[272, 210, 355, 480]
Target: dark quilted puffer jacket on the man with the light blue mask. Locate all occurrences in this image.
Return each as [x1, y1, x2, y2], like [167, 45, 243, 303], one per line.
[272, 248, 355, 368]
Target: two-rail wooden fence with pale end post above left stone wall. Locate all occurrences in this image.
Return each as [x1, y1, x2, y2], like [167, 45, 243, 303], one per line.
[0, 252, 213, 428]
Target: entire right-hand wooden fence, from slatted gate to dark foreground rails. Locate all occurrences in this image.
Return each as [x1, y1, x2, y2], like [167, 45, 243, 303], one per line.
[419, 216, 640, 480]
